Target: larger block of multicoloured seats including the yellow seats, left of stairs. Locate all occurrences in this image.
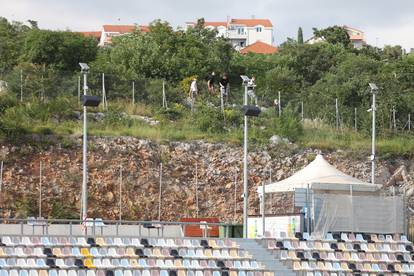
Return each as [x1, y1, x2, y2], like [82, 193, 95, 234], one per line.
[0, 235, 274, 276]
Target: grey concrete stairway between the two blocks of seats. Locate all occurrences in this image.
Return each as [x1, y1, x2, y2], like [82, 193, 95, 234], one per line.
[233, 239, 297, 276]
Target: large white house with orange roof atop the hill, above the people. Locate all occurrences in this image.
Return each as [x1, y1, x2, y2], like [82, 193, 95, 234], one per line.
[186, 19, 274, 49]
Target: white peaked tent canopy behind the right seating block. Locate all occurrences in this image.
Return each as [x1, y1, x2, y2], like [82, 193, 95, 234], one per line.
[258, 155, 381, 194]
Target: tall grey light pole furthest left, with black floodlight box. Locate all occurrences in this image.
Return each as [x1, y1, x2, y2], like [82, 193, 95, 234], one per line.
[79, 63, 101, 222]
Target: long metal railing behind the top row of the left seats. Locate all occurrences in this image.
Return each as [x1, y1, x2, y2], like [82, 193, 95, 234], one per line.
[0, 218, 243, 238]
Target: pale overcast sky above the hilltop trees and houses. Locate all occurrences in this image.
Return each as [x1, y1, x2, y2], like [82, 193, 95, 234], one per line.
[0, 0, 414, 50]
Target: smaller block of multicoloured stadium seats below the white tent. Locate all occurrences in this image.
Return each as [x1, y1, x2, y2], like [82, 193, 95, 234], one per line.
[260, 232, 414, 276]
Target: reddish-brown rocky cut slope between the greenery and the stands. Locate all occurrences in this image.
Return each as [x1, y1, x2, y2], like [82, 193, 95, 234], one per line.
[0, 137, 413, 222]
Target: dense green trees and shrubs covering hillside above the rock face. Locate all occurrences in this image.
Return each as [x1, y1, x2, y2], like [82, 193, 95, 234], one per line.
[0, 18, 414, 154]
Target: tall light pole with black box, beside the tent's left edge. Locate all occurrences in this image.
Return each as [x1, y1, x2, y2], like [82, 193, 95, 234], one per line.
[240, 75, 260, 238]
